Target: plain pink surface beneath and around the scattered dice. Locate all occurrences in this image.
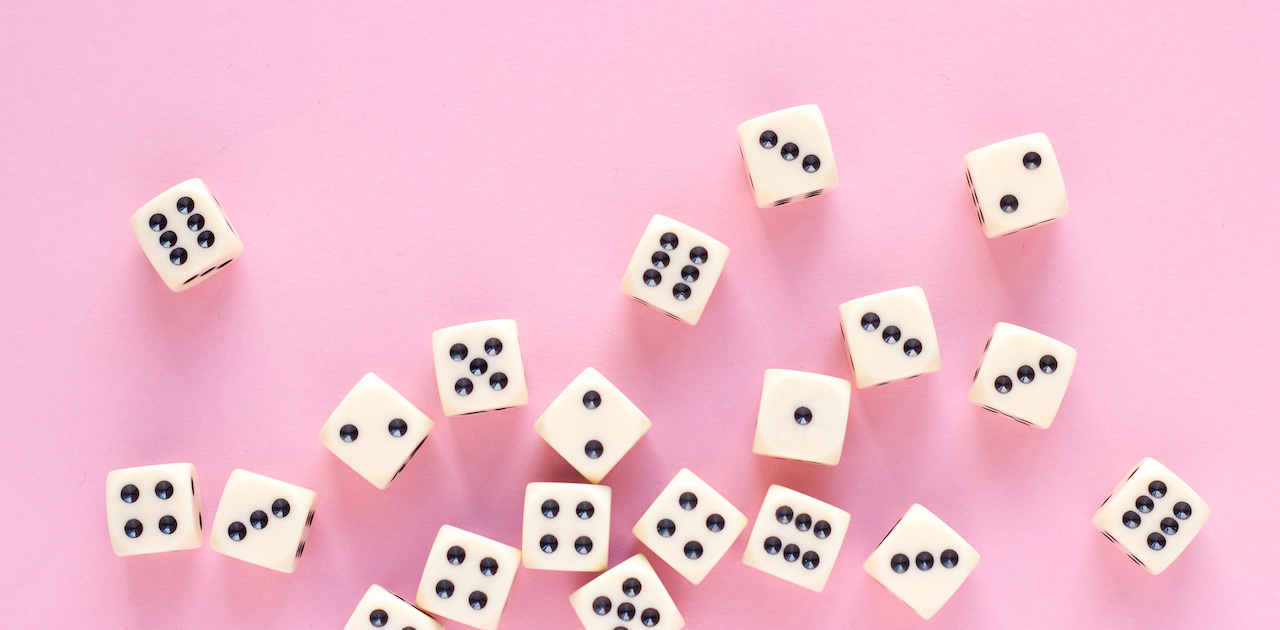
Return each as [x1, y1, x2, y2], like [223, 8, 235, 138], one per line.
[0, 1, 1280, 629]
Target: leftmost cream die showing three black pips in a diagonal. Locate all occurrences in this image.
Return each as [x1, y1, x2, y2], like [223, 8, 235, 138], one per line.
[209, 469, 316, 574]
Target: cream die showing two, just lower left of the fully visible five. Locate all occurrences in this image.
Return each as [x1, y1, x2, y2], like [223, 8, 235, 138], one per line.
[320, 373, 435, 489]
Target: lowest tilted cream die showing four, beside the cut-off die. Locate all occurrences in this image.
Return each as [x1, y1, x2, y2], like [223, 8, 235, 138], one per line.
[416, 525, 520, 630]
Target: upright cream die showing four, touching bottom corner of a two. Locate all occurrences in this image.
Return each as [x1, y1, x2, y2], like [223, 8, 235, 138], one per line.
[520, 483, 613, 571]
